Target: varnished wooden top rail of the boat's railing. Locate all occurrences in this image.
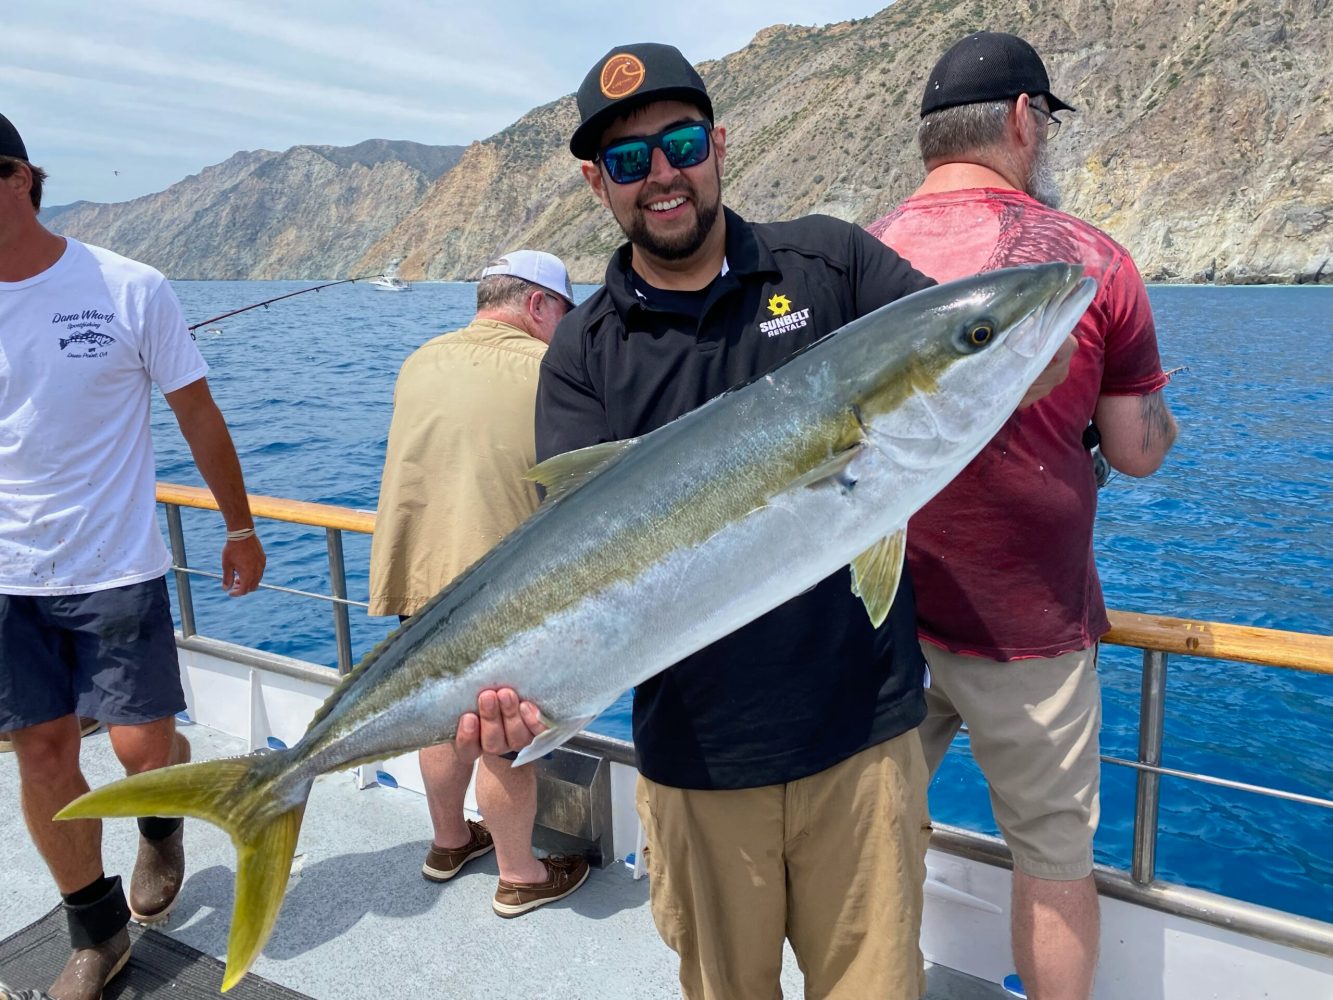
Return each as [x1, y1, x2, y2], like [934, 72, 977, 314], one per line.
[157, 483, 1333, 676]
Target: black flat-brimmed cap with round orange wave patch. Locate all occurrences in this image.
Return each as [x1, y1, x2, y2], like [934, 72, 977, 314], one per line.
[569, 41, 713, 160]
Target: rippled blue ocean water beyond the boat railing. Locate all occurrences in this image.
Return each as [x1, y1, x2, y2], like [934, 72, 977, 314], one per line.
[153, 281, 1333, 920]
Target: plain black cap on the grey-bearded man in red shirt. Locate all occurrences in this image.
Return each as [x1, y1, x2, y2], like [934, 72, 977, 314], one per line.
[921, 31, 1074, 117]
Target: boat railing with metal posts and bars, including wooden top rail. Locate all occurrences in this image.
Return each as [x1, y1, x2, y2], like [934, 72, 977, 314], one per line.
[157, 483, 1333, 955]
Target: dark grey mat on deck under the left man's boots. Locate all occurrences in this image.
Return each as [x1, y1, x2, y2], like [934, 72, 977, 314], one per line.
[0, 907, 309, 1000]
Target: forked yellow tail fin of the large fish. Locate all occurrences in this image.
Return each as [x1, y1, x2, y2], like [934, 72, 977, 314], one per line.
[56, 756, 309, 993]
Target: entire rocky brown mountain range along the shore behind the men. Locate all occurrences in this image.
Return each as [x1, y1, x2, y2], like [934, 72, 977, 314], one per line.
[46, 0, 1333, 283]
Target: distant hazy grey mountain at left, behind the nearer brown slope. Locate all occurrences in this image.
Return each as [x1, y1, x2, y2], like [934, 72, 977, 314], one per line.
[41, 139, 463, 279]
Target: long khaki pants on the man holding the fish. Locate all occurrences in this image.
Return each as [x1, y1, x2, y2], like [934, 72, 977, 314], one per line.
[637, 731, 929, 1000]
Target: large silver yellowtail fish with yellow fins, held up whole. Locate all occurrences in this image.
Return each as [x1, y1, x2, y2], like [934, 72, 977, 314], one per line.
[59, 264, 1096, 991]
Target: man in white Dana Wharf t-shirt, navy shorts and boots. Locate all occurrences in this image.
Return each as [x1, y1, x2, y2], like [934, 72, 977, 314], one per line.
[0, 115, 264, 1000]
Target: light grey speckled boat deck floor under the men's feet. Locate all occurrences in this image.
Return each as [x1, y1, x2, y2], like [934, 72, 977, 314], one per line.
[0, 725, 1006, 1000]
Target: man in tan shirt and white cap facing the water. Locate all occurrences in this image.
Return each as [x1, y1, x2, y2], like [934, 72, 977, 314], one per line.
[371, 251, 588, 917]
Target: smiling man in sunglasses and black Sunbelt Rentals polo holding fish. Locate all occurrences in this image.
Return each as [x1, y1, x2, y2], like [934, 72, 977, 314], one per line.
[471, 44, 1082, 999]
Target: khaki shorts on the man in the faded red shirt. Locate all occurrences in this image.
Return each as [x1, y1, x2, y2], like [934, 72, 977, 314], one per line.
[921, 643, 1101, 880]
